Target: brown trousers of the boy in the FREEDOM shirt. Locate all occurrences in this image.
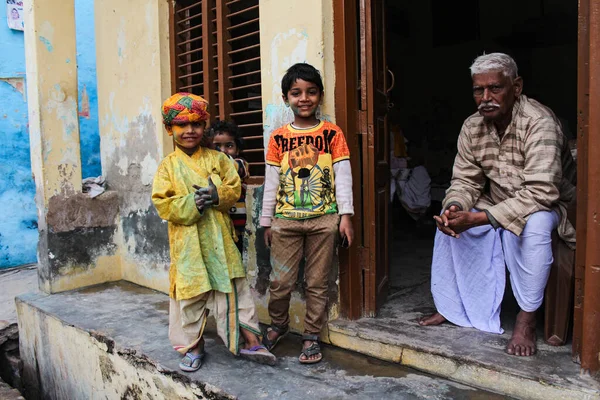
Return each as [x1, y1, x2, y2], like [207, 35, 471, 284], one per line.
[269, 214, 340, 335]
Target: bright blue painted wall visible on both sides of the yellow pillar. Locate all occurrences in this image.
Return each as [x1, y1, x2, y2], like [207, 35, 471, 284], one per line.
[0, 0, 101, 268]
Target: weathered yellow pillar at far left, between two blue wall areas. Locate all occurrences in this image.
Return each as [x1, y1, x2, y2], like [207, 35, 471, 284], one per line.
[25, 1, 81, 208]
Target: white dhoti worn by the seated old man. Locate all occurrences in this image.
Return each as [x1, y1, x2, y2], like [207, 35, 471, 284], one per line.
[431, 211, 560, 333]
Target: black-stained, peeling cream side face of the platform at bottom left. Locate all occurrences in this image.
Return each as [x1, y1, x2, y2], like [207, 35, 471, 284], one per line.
[16, 295, 234, 400]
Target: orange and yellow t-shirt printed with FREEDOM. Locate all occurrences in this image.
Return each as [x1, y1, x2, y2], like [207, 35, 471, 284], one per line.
[266, 121, 350, 219]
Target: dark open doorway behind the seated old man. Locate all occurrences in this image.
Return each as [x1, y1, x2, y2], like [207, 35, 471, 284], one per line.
[379, 0, 578, 330]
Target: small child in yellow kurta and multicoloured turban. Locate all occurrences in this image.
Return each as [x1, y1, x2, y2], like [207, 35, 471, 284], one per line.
[152, 93, 276, 372]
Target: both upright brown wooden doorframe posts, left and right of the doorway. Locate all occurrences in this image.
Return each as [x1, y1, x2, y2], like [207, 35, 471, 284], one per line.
[333, 0, 600, 372]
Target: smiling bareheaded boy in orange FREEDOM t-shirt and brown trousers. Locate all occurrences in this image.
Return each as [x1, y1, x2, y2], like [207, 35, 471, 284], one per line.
[260, 63, 354, 364]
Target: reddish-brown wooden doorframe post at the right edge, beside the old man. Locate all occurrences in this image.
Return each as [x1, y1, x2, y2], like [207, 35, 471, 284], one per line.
[573, 0, 600, 372]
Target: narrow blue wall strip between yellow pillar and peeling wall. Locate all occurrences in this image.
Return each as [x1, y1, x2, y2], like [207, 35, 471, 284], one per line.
[75, 0, 102, 178]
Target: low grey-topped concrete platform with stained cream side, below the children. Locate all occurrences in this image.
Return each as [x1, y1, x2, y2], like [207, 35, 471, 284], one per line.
[16, 282, 506, 400]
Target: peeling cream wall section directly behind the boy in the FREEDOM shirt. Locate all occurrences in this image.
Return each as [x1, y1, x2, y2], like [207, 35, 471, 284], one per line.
[244, 0, 339, 332]
